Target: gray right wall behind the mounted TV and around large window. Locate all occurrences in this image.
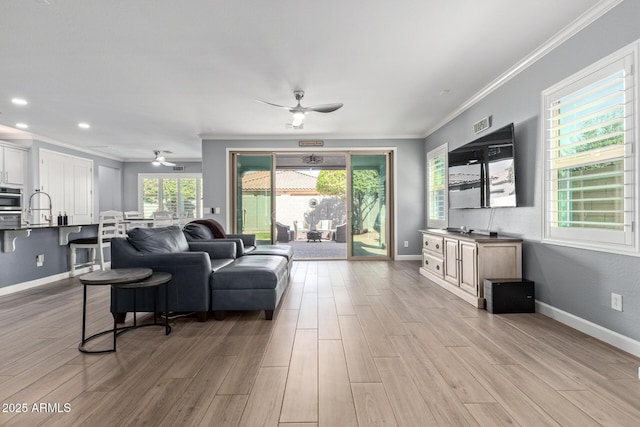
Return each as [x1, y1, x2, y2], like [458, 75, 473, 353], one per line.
[425, 1, 640, 340]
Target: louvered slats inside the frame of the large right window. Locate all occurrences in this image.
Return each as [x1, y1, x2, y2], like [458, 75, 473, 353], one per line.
[547, 69, 633, 231]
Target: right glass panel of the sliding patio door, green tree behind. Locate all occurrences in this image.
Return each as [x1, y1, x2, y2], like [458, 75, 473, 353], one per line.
[347, 152, 392, 259]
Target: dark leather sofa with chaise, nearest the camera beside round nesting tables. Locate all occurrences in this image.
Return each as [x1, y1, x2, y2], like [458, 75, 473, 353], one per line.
[111, 226, 289, 321]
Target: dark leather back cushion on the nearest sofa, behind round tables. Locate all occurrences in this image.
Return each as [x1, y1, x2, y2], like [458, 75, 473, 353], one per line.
[127, 225, 189, 254]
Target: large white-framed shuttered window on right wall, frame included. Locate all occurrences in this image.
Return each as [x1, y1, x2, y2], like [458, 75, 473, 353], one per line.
[543, 40, 637, 252]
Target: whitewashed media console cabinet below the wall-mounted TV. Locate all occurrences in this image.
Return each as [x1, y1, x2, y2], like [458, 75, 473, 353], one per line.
[420, 229, 522, 308]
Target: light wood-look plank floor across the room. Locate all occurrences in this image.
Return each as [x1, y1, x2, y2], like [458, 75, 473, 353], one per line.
[0, 261, 640, 427]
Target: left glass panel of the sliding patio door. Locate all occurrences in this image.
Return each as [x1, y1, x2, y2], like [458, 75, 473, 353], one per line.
[232, 153, 275, 245]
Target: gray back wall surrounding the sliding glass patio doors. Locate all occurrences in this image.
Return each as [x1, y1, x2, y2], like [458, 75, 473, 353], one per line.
[202, 139, 425, 255]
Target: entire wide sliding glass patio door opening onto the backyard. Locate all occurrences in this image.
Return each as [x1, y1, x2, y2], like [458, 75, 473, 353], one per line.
[231, 151, 393, 259]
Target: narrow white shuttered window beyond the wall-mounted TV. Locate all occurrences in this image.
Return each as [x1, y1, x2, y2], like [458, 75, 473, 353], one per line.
[427, 144, 448, 228]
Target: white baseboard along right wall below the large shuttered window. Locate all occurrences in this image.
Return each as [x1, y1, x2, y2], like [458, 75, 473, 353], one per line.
[536, 301, 640, 357]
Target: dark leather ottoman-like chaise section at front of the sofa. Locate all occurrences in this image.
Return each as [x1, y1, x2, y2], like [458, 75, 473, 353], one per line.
[209, 255, 289, 320]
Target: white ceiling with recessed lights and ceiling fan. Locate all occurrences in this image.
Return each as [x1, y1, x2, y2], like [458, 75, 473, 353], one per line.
[0, 0, 615, 160]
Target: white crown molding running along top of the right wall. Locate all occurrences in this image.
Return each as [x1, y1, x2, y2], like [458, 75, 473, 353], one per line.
[422, 0, 624, 138]
